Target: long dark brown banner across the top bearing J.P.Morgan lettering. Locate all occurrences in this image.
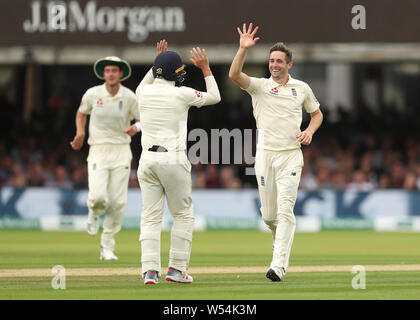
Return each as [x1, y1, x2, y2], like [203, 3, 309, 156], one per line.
[0, 0, 420, 46]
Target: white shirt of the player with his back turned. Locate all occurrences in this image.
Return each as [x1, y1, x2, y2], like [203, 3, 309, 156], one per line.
[136, 78, 207, 152]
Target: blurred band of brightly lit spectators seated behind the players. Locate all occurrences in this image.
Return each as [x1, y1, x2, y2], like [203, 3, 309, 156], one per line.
[0, 134, 420, 191]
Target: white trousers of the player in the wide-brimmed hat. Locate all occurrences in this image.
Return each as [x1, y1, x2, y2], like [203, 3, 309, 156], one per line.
[87, 144, 132, 251]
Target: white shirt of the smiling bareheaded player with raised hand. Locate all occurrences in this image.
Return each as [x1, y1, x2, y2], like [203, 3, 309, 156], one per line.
[244, 76, 319, 151]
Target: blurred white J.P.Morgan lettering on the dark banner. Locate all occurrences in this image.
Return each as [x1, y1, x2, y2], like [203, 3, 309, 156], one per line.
[22, 0, 186, 43]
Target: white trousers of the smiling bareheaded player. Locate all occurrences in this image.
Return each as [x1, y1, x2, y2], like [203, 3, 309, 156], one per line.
[255, 149, 303, 270]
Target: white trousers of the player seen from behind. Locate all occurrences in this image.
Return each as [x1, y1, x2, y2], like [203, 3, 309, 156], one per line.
[137, 150, 194, 273]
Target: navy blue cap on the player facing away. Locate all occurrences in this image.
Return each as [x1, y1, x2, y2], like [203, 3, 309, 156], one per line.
[153, 51, 185, 82]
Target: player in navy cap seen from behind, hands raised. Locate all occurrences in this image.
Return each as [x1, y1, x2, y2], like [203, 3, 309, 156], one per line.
[136, 43, 220, 284]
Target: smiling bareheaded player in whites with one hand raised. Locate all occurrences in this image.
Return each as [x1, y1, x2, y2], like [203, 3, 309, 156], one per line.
[229, 23, 323, 281]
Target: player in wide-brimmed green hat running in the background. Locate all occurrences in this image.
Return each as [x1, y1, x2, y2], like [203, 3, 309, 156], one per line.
[71, 57, 140, 260]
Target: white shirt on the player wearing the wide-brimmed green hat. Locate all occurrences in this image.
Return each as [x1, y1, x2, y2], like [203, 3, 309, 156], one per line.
[79, 84, 140, 146]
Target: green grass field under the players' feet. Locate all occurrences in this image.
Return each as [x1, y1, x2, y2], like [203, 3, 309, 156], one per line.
[0, 231, 420, 300]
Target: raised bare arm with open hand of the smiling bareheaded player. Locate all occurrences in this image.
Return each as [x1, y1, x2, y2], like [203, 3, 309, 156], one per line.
[229, 23, 260, 89]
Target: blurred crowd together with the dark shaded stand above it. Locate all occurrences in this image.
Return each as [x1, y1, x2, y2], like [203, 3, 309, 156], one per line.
[0, 64, 420, 191]
